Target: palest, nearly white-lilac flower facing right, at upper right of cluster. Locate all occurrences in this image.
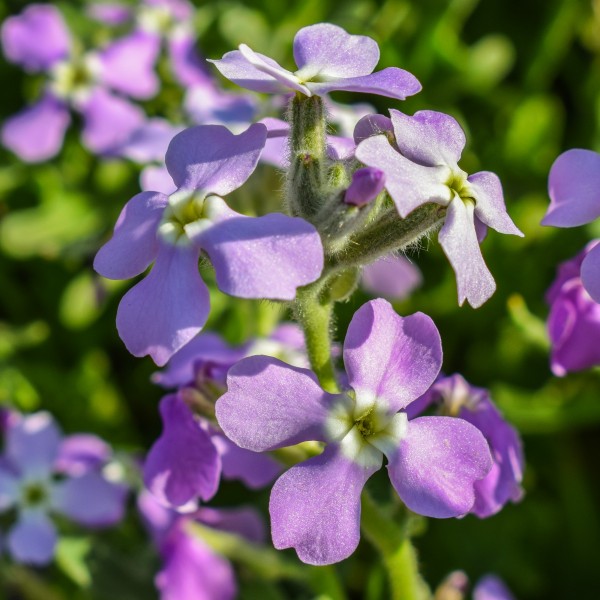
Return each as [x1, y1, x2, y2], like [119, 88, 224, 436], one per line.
[355, 110, 523, 308]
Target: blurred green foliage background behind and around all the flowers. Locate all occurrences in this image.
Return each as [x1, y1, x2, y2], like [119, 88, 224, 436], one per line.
[0, 0, 600, 600]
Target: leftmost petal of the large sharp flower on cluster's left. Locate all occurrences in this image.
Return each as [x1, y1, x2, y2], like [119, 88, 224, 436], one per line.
[94, 192, 168, 279]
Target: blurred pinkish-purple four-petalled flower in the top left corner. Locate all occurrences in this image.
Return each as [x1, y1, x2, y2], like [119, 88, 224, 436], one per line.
[1, 4, 158, 162]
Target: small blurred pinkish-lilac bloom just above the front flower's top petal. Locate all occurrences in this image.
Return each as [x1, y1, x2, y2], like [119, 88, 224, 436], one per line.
[361, 254, 423, 300]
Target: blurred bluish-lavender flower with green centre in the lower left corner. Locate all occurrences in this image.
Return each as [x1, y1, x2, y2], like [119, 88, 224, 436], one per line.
[0, 412, 126, 565]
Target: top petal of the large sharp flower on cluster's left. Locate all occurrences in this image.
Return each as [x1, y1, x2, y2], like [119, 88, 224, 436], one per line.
[165, 123, 267, 196]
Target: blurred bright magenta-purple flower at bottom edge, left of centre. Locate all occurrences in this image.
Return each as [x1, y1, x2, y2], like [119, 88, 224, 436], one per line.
[138, 492, 264, 600]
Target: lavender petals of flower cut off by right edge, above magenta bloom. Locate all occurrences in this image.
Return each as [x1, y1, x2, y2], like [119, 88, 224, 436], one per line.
[542, 148, 600, 302]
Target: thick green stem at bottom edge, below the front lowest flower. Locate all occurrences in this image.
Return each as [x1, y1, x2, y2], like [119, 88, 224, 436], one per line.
[361, 490, 429, 600]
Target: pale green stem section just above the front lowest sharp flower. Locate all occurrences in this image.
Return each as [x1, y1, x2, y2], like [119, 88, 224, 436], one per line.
[295, 280, 339, 393]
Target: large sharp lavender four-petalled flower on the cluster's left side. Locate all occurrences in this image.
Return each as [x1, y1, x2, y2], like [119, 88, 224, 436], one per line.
[94, 124, 323, 366]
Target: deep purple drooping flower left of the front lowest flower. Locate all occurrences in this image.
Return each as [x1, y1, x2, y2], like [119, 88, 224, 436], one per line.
[144, 393, 281, 511]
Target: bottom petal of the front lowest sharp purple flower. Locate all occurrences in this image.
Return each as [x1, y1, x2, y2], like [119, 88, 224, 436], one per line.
[269, 444, 379, 565]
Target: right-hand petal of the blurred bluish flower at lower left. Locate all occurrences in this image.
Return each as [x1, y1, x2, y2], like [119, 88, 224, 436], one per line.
[51, 471, 127, 527]
